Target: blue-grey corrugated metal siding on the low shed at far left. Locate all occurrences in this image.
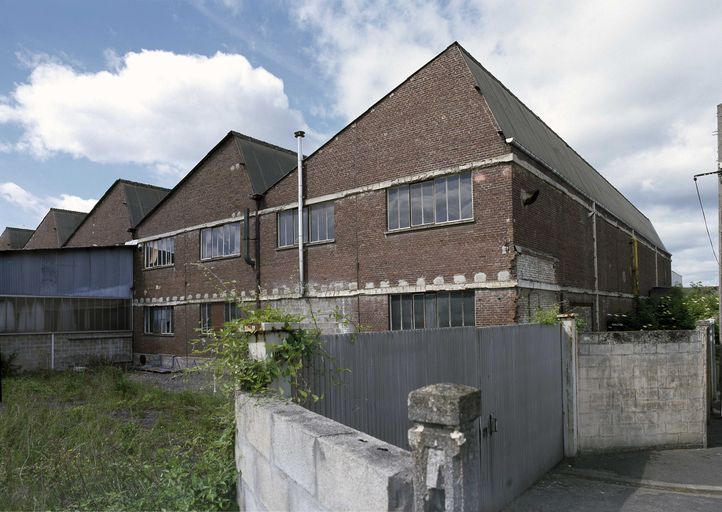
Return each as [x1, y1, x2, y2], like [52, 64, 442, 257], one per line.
[0, 247, 133, 299]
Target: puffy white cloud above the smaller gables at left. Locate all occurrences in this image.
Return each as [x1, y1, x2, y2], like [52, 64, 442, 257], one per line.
[0, 50, 315, 174]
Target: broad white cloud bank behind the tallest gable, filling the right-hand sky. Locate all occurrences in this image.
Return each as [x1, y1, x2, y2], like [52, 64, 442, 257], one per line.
[294, 0, 722, 282]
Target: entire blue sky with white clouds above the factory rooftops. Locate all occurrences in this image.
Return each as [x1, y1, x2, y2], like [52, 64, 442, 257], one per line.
[0, 0, 722, 284]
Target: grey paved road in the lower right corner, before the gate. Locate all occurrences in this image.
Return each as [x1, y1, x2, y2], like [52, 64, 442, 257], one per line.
[506, 419, 722, 512]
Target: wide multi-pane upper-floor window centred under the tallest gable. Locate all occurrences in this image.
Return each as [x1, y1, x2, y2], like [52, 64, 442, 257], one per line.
[387, 172, 474, 230]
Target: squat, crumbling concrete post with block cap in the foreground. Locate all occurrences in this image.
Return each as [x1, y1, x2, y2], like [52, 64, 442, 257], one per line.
[409, 384, 481, 512]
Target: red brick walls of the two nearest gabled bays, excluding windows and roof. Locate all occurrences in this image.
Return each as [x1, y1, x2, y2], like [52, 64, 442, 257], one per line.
[129, 46, 670, 355]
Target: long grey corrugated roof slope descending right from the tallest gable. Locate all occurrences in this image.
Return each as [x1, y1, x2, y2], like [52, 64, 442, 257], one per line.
[459, 45, 666, 251]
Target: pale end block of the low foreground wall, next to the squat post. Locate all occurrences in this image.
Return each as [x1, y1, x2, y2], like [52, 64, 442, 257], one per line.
[316, 431, 413, 511]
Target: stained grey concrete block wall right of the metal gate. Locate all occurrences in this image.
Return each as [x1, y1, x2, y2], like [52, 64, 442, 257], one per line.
[577, 331, 707, 452]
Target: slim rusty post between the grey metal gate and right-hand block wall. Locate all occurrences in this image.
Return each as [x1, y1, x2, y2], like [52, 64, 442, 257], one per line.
[557, 313, 579, 457]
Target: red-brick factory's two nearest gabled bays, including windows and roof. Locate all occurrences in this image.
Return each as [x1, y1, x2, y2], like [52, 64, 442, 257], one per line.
[131, 43, 671, 355]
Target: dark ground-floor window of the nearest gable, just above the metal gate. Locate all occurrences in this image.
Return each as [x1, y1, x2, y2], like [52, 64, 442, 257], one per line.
[389, 290, 475, 331]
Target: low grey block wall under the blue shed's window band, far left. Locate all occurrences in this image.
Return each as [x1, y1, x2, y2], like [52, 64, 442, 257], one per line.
[0, 331, 133, 371]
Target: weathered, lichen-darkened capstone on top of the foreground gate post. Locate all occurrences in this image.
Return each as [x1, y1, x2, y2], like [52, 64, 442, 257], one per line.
[408, 383, 481, 426]
